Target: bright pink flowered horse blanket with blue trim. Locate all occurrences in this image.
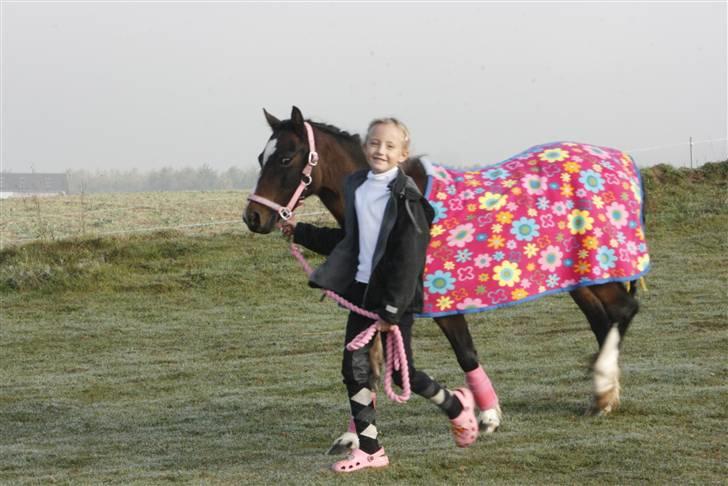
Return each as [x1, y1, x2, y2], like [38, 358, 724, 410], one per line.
[419, 142, 650, 317]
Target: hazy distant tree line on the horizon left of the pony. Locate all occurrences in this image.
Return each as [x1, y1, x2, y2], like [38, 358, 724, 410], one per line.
[67, 164, 258, 194]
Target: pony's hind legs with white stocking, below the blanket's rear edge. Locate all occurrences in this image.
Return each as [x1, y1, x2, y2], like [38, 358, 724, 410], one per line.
[571, 283, 636, 415]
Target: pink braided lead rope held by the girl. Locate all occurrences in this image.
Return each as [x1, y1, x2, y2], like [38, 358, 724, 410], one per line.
[291, 243, 412, 403]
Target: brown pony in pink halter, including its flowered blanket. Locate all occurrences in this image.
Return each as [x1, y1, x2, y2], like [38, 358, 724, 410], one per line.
[243, 106, 649, 447]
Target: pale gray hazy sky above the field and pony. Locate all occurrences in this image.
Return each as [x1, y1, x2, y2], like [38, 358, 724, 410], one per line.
[1, 1, 728, 172]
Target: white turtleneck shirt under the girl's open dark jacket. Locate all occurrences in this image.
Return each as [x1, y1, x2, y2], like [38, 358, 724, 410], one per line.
[354, 167, 399, 283]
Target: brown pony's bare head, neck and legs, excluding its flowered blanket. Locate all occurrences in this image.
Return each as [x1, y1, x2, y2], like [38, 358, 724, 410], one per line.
[243, 107, 638, 448]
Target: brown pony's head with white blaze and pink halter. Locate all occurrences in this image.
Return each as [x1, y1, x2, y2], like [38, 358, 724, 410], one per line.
[243, 106, 312, 234]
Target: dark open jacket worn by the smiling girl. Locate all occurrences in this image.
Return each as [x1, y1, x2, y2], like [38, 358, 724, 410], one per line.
[293, 169, 434, 324]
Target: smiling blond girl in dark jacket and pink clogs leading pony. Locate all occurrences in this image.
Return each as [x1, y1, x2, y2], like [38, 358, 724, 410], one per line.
[282, 118, 478, 472]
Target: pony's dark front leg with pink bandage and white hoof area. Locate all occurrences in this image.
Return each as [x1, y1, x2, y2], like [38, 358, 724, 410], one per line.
[435, 314, 503, 434]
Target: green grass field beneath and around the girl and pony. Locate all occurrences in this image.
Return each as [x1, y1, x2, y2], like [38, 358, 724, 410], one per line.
[0, 162, 728, 484]
